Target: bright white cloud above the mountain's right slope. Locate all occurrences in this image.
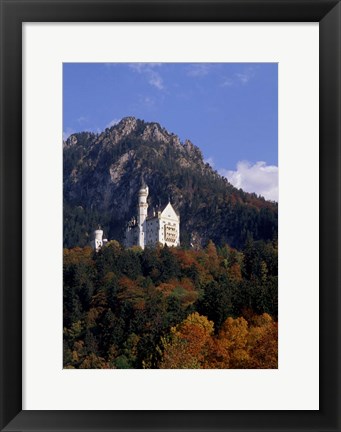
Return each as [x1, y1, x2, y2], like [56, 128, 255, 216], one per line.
[219, 161, 278, 201]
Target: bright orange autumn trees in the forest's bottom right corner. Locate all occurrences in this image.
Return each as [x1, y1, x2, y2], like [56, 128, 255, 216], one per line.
[160, 312, 278, 369]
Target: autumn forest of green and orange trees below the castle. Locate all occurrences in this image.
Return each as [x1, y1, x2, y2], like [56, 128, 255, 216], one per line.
[63, 237, 278, 369]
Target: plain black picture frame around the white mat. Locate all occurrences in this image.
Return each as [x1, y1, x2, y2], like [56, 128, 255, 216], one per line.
[0, 0, 341, 432]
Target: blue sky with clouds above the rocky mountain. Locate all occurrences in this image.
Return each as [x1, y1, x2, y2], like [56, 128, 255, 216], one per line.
[63, 63, 278, 201]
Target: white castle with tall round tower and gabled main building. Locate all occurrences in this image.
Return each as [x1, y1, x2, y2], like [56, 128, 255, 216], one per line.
[124, 185, 180, 249]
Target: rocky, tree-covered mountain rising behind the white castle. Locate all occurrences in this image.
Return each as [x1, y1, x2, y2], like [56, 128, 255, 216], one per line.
[63, 117, 278, 248]
